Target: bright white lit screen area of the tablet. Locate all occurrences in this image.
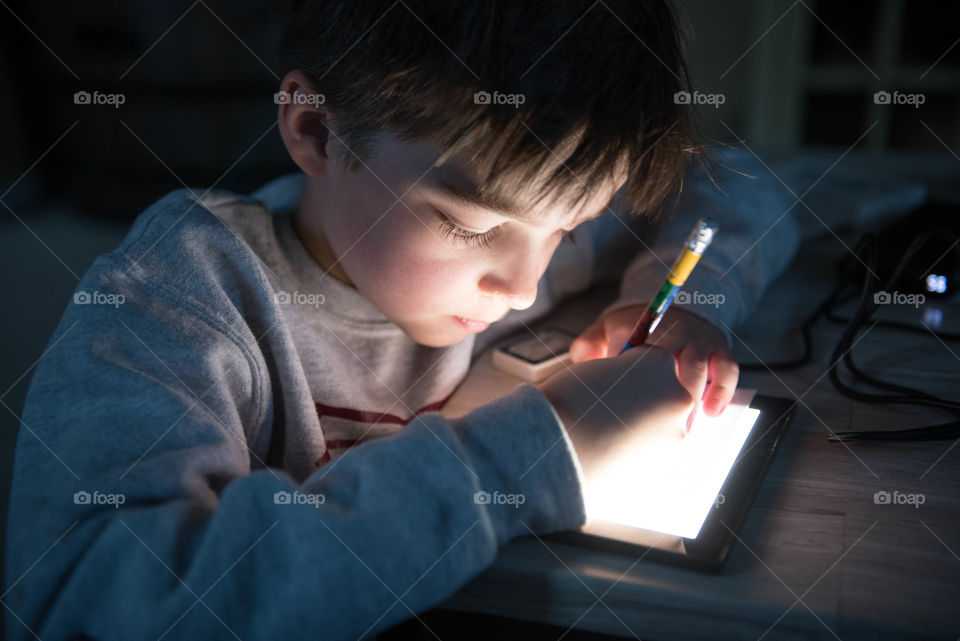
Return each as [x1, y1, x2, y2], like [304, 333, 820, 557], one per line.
[585, 389, 760, 539]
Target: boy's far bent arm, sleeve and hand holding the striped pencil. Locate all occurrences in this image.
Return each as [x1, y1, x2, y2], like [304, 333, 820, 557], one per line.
[571, 151, 798, 415]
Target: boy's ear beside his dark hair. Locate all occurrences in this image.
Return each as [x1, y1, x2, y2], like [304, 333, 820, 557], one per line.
[276, 70, 332, 178]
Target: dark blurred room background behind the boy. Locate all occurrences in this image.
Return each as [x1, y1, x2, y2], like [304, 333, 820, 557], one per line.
[0, 0, 960, 632]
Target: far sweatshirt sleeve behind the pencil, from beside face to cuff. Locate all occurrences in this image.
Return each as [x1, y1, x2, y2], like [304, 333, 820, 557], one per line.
[536, 149, 799, 340]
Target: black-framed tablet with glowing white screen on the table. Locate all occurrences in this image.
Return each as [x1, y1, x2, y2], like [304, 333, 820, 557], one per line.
[549, 390, 795, 572]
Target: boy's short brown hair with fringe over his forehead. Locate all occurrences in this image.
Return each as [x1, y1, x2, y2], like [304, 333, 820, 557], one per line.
[280, 0, 705, 214]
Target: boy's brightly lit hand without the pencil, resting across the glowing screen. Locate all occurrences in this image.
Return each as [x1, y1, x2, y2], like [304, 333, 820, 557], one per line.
[540, 346, 693, 487]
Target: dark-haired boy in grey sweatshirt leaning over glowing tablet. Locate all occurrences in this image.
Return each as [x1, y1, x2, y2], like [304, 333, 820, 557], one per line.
[5, 0, 793, 640]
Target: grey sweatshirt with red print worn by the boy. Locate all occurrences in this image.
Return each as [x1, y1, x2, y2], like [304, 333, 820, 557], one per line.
[4, 155, 796, 641]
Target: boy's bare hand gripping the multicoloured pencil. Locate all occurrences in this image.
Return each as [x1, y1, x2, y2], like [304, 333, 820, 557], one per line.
[570, 305, 740, 416]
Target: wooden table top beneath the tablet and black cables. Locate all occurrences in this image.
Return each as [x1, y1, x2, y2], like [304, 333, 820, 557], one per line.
[443, 235, 960, 641]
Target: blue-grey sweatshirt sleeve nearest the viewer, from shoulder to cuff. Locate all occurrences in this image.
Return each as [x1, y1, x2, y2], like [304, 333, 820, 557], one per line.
[4, 252, 585, 641]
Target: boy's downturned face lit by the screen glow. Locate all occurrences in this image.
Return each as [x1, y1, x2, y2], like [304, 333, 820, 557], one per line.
[296, 134, 623, 347]
